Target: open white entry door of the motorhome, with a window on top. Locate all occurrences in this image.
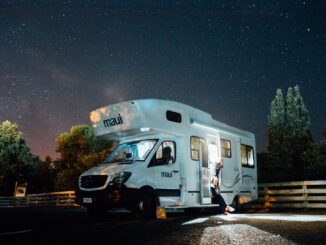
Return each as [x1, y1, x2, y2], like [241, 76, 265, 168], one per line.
[199, 143, 211, 204]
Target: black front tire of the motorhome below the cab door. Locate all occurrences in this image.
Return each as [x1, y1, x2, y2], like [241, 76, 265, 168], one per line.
[136, 191, 157, 219]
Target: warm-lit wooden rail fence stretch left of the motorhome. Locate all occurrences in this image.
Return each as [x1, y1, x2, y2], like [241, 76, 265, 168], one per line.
[0, 191, 78, 208]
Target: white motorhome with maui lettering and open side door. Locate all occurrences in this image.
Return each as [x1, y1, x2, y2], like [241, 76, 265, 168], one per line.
[77, 99, 257, 216]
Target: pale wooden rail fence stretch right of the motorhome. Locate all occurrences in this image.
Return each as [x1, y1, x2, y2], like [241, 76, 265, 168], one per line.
[256, 180, 326, 209]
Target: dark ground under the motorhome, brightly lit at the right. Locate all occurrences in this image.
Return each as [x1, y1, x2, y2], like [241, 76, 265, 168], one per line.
[0, 209, 326, 245]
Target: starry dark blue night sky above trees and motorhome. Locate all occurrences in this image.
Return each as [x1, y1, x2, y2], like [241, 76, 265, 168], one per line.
[0, 0, 326, 158]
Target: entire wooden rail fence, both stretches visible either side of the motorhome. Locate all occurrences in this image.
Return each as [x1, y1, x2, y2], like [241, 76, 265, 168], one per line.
[0, 180, 326, 209]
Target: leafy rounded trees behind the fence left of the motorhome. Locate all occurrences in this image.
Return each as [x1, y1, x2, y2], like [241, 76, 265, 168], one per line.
[0, 121, 112, 196]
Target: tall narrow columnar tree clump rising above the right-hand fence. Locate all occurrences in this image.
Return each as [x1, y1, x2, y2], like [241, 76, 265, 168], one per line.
[268, 86, 313, 180]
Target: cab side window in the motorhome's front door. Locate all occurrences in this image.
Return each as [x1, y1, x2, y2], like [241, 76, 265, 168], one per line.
[148, 141, 176, 167]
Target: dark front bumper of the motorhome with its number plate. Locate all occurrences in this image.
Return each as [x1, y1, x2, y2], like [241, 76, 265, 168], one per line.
[76, 185, 137, 209]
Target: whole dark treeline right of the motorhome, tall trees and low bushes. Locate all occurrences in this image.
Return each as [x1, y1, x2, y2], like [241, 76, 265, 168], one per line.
[258, 86, 326, 182]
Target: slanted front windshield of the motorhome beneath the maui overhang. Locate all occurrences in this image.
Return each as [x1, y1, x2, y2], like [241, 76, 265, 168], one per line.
[104, 140, 157, 164]
